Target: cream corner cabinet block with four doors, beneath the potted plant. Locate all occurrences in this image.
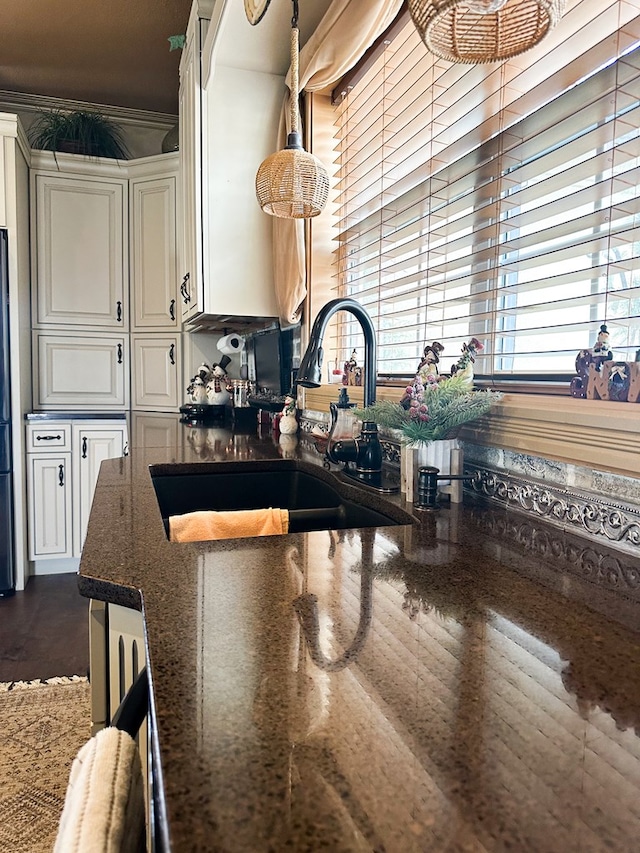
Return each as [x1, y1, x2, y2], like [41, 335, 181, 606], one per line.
[31, 151, 181, 412]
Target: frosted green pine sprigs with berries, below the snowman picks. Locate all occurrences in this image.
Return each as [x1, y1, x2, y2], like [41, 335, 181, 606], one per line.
[355, 374, 502, 445]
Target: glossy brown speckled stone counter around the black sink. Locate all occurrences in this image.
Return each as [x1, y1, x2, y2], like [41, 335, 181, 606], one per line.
[79, 429, 640, 853]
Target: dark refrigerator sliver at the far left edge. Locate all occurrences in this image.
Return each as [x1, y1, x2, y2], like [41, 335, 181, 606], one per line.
[0, 229, 15, 597]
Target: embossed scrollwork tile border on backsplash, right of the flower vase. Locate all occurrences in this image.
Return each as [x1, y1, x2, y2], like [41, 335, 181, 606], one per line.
[465, 465, 640, 557]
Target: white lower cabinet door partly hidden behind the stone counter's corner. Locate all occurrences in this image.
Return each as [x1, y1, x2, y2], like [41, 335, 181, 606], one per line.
[73, 423, 127, 557]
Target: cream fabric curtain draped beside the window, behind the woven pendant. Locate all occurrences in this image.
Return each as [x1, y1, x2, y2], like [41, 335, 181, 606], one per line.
[273, 0, 402, 327]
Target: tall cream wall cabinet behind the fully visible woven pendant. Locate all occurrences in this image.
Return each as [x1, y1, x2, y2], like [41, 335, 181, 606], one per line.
[179, 2, 280, 328]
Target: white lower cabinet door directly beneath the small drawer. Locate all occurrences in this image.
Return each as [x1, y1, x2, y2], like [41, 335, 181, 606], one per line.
[27, 453, 73, 560]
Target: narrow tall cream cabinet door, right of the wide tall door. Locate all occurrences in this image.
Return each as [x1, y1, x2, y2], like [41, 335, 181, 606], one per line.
[131, 176, 180, 329]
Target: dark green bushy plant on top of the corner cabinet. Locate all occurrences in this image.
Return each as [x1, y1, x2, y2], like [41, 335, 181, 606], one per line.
[29, 110, 129, 160]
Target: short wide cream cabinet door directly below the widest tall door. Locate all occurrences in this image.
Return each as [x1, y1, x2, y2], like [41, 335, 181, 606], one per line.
[34, 332, 129, 411]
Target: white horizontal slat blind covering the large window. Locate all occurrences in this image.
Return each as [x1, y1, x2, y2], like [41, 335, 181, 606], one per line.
[336, 0, 640, 378]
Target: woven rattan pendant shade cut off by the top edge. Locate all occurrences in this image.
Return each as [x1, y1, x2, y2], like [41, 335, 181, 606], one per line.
[409, 0, 565, 64]
